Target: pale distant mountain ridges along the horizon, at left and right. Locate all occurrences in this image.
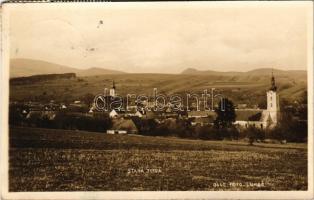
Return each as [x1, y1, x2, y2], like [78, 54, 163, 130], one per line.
[10, 58, 307, 78]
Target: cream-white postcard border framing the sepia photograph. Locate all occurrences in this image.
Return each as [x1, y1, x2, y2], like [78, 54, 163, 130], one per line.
[0, 1, 314, 199]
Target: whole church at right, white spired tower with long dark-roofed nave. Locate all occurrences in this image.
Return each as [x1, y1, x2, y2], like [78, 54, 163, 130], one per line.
[234, 73, 280, 129]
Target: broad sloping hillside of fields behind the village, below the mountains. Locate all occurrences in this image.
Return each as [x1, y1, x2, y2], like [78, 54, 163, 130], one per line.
[10, 73, 307, 105]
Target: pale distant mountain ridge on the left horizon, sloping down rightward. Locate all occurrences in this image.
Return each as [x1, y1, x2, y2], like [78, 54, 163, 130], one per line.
[10, 58, 125, 78]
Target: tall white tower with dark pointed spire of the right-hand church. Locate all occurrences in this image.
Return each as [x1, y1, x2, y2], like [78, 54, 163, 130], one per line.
[267, 72, 279, 126]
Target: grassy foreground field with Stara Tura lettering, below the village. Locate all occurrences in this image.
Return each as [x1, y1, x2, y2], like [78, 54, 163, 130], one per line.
[9, 127, 307, 191]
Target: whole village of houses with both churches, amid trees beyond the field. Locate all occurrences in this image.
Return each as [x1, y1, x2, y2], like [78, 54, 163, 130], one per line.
[10, 72, 279, 138]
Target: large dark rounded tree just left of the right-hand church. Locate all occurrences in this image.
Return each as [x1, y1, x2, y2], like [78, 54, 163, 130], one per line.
[214, 98, 236, 129]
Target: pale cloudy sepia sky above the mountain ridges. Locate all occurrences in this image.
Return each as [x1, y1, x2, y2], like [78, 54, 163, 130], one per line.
[9, 2, 312, 73]
